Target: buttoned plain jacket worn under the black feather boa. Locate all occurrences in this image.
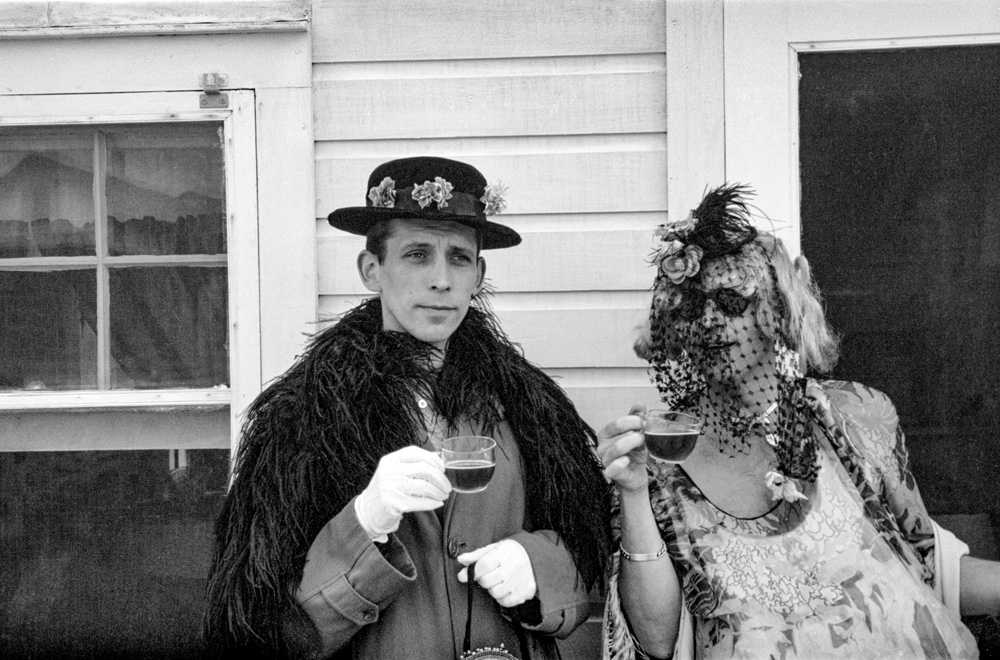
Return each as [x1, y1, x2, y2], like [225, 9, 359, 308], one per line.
[297, 424, 589, 660]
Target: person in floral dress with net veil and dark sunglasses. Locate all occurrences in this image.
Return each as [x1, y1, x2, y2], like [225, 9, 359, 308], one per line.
[598, 186, 1000, 660]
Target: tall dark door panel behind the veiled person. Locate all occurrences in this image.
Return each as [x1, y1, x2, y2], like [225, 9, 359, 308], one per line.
[799, 46, 1000, 514]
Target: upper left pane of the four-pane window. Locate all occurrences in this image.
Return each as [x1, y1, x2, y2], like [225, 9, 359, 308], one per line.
[0, 127, 94, 259]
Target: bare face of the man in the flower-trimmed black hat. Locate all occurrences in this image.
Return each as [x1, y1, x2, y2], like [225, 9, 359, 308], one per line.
[358, 220, 486, 350]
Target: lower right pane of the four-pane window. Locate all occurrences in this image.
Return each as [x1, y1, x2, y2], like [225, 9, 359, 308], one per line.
[109, 266, 229, 389]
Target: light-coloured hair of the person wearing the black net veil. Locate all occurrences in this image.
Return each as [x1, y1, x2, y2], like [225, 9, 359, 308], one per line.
[634, 231, 838, 372]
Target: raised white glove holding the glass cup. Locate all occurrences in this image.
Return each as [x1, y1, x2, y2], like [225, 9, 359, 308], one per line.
[354, 446, 451, 543]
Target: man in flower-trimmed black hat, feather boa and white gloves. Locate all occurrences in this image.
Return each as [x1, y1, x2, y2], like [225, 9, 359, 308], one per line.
[205, 157, 611, 660]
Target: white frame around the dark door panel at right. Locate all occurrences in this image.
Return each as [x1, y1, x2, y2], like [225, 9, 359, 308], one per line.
[722, 0, 1000, 257]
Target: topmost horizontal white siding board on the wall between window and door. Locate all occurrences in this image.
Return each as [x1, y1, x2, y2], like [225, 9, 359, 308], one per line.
[313, 0, 666, 62]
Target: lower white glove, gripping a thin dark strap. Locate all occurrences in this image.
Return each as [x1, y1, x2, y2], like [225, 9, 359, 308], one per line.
[456, 539, 538, 607]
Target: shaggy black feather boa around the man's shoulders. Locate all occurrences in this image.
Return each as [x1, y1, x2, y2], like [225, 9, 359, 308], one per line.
[205, 298, 612, 657]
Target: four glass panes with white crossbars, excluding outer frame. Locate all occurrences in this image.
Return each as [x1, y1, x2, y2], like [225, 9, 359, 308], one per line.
[0, 122, 229, 391]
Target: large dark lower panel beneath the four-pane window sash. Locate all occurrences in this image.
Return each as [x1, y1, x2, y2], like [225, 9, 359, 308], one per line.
[0, 450, 228, 660]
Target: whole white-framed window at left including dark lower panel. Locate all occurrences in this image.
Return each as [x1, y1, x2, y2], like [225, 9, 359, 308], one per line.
[0, 90, 260, 658]
